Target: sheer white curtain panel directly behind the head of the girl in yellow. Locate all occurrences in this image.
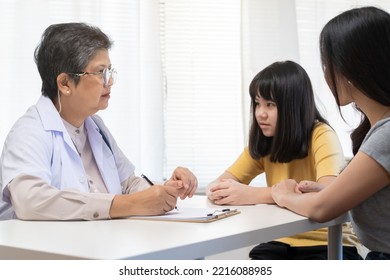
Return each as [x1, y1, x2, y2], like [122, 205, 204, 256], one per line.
[242, 0, 299, 141]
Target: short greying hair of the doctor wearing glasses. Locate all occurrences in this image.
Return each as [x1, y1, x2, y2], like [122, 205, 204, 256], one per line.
[34, 23, 112, 102]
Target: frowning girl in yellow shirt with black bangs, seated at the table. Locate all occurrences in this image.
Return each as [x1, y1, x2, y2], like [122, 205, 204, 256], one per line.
[207, 61, 360, 259]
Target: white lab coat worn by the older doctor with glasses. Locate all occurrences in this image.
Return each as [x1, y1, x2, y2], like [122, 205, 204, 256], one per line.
[0, 96, 134, 206]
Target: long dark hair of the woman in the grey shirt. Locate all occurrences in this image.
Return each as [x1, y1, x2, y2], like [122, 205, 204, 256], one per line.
[320, 7, 390, 154]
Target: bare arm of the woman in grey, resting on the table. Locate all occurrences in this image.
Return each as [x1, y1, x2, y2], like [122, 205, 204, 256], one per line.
[272, 152, 390, 222]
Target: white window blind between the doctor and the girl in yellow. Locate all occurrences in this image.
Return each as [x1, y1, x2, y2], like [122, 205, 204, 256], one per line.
[160, 0, 244, 188]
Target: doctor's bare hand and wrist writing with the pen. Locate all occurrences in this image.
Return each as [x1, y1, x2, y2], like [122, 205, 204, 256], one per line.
[110, 185, 179, 218]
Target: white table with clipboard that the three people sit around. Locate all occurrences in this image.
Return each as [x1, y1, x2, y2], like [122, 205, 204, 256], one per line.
[0, 196, 347, 260]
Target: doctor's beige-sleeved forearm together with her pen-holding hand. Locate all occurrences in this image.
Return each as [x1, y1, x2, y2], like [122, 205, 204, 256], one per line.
[7, 174, 179, 220]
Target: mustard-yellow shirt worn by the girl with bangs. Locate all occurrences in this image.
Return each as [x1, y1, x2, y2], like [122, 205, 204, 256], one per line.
[227, 123, 357, 246]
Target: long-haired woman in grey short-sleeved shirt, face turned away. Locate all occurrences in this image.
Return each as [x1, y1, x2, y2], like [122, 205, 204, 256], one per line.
[272, 7, 390, 259]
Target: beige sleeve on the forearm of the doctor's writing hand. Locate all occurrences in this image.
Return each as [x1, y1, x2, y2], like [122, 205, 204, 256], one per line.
[7, 174, 114, 220]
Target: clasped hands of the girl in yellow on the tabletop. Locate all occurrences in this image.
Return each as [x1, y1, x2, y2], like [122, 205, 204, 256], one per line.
[206, 179, 256, 205]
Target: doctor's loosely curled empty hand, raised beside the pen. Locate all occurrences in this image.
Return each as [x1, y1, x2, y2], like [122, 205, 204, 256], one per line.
[164, 167, 198, 199]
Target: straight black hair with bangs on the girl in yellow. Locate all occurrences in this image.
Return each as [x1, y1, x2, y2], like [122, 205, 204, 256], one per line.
[248, 61, 327, 163]
